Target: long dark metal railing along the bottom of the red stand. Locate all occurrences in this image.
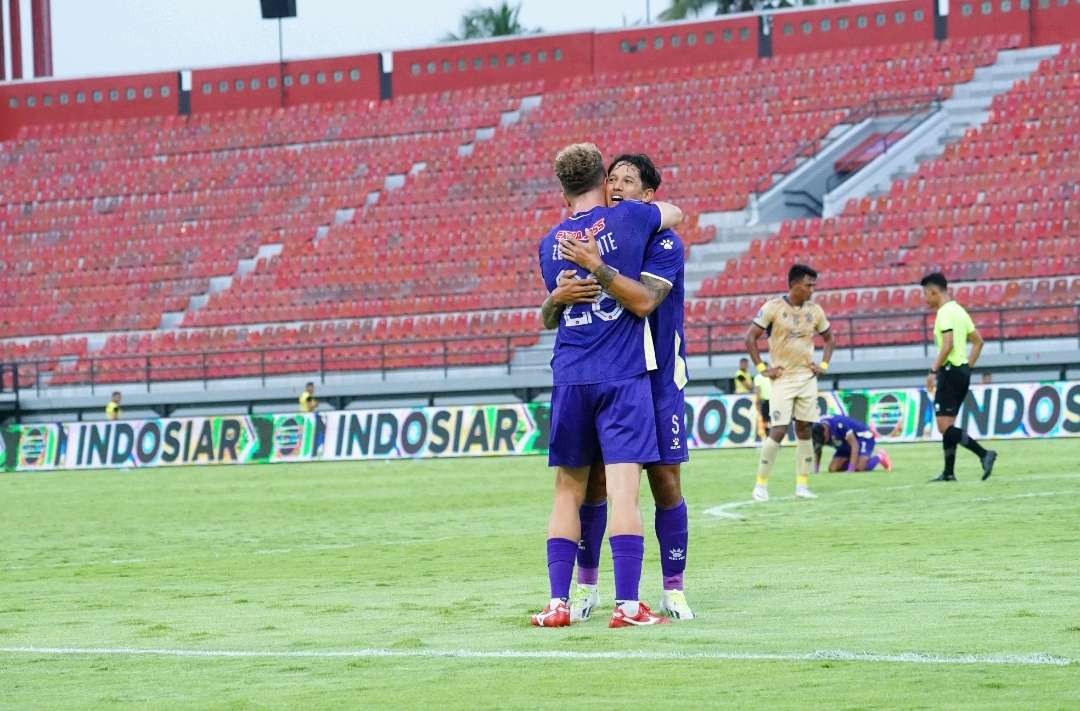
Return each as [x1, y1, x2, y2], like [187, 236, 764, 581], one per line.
[4, 299, 1080, 394]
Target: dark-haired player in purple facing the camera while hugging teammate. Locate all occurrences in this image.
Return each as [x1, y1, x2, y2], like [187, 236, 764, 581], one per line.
[552, 153, 693, 621]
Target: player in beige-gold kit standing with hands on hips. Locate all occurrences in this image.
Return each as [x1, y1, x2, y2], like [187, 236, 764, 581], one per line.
[746, 264, 833, 501]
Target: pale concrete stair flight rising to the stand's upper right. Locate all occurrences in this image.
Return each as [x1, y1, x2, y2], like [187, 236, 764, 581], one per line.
[820, 44, 1061, 218]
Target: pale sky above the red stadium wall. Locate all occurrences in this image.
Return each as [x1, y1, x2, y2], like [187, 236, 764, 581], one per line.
[44, 0, 656, 78]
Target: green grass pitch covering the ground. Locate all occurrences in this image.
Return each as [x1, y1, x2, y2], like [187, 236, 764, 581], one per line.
[0, 440, 1080, 711]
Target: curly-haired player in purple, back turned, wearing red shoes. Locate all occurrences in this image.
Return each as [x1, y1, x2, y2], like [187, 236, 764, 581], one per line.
[531, 144, 683, 627]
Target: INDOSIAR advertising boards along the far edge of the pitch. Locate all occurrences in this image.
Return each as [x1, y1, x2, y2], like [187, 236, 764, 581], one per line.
[0, 380, 1080, 472]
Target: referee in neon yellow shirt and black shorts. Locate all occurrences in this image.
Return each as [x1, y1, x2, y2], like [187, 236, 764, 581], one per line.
[919, 271, 998, 482]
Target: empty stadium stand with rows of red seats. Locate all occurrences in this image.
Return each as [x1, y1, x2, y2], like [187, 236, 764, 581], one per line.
[0, 2, 1080, 397]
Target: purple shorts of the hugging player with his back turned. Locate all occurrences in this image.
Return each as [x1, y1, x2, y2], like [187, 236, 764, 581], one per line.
[548, 373, 659, 467]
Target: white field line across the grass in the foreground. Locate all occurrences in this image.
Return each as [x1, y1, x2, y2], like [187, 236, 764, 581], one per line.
[0, 647, 1067, 667]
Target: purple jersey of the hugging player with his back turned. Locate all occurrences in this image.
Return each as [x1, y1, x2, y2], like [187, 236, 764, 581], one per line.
[540, 200, 660, 385]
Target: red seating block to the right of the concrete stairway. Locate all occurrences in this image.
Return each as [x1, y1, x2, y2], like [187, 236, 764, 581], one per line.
[688, 43, 1080, 360]
